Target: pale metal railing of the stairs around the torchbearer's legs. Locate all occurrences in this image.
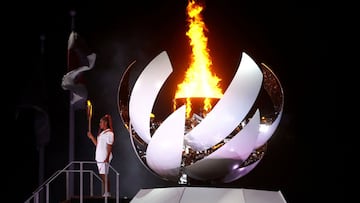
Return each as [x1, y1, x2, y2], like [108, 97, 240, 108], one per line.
[24, 161, 120, 203]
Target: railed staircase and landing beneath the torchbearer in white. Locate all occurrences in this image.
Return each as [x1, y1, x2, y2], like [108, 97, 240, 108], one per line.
[24, 161, 122, 203]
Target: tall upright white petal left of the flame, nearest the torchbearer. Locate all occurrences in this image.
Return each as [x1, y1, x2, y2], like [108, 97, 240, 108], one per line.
[129, 51, 172, 143]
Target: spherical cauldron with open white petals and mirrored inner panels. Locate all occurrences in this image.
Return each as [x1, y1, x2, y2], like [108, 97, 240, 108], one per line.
[118, 51, 284, 183]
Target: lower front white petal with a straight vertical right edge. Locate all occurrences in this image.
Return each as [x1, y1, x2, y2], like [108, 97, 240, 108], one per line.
[146, 105, 185, 178]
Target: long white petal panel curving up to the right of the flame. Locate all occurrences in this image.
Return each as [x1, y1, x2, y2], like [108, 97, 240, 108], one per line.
[185, 53, 263, 151]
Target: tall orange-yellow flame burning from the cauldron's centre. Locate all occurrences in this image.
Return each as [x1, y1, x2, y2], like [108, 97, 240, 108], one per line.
[175, 0, 223, 117]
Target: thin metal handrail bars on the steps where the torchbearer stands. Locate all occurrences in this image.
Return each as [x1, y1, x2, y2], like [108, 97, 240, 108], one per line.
[24, 161, 120, 203]
